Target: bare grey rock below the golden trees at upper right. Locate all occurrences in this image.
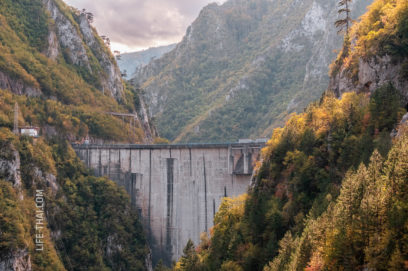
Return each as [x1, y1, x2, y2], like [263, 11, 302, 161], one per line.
[329, 55, 408, 101]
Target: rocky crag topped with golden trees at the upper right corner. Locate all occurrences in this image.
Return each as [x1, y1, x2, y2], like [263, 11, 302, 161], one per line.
[329, 1, 408, 98]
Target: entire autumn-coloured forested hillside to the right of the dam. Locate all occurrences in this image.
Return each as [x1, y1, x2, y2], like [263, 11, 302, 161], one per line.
[174, 0, 408, 271]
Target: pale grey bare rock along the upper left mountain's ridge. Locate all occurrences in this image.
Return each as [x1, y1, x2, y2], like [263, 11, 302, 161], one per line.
[43, 0, 123, 101]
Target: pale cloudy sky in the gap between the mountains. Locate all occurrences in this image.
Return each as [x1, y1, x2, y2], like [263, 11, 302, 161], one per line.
[65, 0, 225, 52]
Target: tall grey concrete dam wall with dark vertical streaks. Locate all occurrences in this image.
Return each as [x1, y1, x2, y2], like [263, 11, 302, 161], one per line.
[73, 142, 265, 263]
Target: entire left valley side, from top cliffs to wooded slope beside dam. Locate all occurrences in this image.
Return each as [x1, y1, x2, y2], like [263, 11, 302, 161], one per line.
[0, 0, 152, 271]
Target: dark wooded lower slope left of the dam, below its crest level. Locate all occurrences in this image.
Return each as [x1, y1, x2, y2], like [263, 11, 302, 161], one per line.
[0, 131, 149, 271]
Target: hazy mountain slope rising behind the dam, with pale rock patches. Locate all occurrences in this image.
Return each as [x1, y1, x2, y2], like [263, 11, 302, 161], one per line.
[134, 0, 371, 142]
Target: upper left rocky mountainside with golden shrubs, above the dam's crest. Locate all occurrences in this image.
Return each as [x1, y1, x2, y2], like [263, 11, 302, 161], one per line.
[0, 0, 157, 143]
